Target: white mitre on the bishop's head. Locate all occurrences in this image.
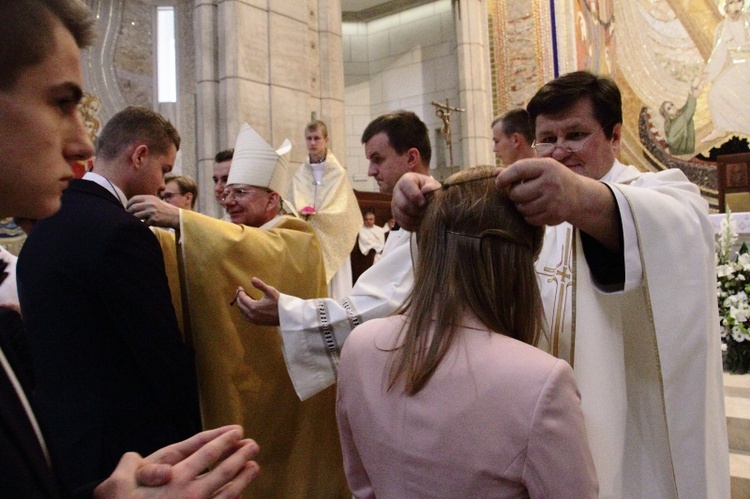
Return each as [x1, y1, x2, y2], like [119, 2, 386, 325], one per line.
[227, 123, 292, 194]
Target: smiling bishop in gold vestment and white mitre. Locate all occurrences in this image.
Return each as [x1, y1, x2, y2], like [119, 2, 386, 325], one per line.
[128, 124, 350, 498]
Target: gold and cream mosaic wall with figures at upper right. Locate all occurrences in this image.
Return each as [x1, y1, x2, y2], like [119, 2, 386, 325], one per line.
[488, 0, 750, 204]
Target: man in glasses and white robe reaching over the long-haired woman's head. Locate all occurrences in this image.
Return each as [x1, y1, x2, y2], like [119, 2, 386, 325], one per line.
[394, 71, 729, 498]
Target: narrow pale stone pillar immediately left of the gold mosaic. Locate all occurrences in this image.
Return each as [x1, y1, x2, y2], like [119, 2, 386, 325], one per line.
[453, 0, 495, 167]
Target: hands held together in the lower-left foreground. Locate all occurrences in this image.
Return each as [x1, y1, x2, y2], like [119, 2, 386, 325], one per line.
[94, 425, 259, 498]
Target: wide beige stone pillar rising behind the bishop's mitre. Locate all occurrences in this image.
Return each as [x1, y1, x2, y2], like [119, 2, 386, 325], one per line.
[217, 0, 344, 171]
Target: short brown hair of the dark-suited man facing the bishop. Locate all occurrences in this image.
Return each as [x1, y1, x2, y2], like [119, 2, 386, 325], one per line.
[96, 106, 180, 160]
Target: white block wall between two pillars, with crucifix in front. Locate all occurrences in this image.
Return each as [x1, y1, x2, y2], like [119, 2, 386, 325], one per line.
[342, 0, 461, 191]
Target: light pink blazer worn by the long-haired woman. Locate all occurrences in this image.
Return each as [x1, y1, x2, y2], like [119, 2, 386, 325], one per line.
[337, 316, 598, 499]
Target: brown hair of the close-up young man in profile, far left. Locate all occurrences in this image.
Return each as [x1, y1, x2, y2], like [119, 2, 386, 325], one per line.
[0, 0, 94, 90]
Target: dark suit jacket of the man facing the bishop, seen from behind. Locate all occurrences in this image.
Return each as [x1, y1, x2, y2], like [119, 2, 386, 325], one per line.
[17, 180, 199, 488]
